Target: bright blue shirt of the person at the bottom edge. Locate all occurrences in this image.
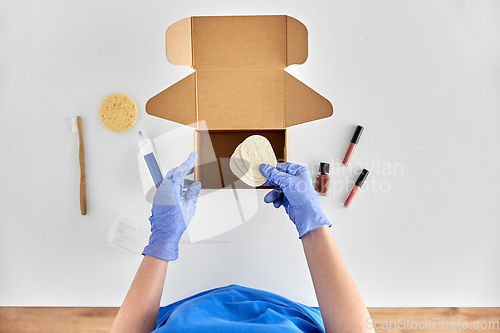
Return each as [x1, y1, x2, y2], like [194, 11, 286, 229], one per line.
[153, 284, 325, 333]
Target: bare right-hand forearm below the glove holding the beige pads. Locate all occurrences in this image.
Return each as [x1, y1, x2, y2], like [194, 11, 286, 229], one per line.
[302, 226, 373, 333]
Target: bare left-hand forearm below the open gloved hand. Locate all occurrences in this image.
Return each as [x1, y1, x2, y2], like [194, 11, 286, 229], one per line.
[110, 255, 168, 333]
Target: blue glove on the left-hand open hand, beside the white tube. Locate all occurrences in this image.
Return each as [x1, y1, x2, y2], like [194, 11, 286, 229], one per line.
[142, 151, 201, 261]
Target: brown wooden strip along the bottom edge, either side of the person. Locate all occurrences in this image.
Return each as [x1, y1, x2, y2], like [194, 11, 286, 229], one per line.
[0, 307, 500, 333]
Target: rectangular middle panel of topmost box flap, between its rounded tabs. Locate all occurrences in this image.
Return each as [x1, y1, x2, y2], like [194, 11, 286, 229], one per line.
[191, 15, 287, 71]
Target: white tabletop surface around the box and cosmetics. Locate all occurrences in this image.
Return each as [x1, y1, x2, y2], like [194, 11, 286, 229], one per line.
[0, 0, 500, 306]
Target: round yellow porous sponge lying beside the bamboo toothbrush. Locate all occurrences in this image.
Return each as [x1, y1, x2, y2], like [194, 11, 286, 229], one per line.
[100, 94, 137, 132]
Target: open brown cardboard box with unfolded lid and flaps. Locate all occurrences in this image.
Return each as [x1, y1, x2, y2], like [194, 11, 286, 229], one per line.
[146, 15, 333, 189]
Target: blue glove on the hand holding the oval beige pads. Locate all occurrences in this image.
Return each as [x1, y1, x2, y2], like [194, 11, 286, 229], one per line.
[260, 163, 332, 238]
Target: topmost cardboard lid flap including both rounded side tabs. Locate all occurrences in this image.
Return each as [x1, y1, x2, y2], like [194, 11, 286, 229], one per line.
[165, 15, 307, 71]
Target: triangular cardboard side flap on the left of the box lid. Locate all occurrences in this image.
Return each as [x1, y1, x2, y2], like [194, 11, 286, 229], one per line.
[146, 73, 198, 125]
